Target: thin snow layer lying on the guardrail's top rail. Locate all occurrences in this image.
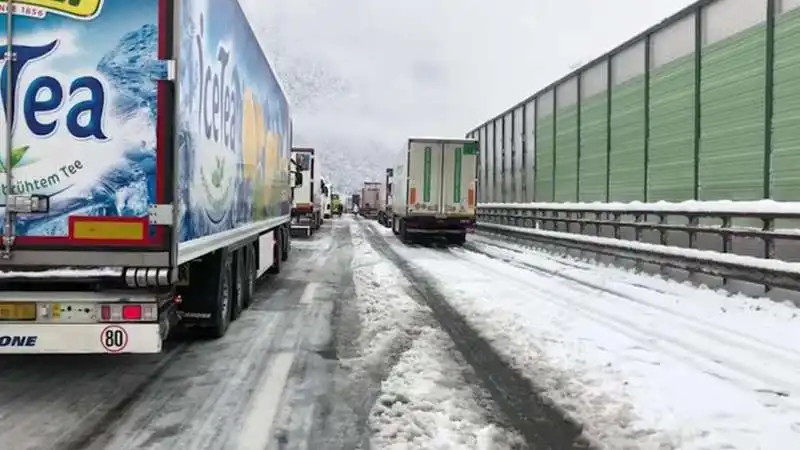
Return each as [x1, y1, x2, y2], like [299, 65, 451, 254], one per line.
[478, 200, 800, 214]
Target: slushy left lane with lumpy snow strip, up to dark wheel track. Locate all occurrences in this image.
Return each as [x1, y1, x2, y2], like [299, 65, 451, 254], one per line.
[0, 218, 524, 450]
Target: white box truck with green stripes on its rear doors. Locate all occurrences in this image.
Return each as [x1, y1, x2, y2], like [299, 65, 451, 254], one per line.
[392, 138, 478, 245]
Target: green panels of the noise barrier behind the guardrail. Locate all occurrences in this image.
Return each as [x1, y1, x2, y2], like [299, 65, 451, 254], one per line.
[478, 3, 800, 202]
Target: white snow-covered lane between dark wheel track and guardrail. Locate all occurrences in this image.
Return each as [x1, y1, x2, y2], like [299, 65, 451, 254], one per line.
[373, 222, 800, 449]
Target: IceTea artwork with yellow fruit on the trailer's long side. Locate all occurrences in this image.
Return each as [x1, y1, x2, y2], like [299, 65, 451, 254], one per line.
[178, 0, 291, 242]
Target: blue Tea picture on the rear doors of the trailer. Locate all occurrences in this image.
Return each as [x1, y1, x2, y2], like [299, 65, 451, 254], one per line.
[0, 0, 158, 243]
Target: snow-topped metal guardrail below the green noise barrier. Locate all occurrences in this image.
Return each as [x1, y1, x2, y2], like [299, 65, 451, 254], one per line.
[478, 201, 800, 291]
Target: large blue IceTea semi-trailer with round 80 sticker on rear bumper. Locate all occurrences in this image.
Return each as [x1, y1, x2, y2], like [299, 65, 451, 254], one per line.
[0, 0, 303, 354]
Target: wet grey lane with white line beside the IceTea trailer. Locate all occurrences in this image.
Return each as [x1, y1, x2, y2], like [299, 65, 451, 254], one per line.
[0, 221, 357, 450]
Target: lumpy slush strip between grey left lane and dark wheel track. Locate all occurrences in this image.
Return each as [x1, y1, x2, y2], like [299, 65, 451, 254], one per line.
[351, 224, 521, 450]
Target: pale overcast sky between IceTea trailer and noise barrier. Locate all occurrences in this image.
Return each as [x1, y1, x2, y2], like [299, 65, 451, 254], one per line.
[240, 0, 692, 189]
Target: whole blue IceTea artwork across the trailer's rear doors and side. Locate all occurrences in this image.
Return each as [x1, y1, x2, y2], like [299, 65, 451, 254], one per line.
[0, 0, 291, 245]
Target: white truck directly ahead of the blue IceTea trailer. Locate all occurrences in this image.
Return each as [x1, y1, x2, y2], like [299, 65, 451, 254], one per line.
[292, 147, 322, 236]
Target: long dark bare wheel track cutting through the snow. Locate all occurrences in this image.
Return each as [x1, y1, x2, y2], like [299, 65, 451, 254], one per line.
[364, 226, 591, 450]
